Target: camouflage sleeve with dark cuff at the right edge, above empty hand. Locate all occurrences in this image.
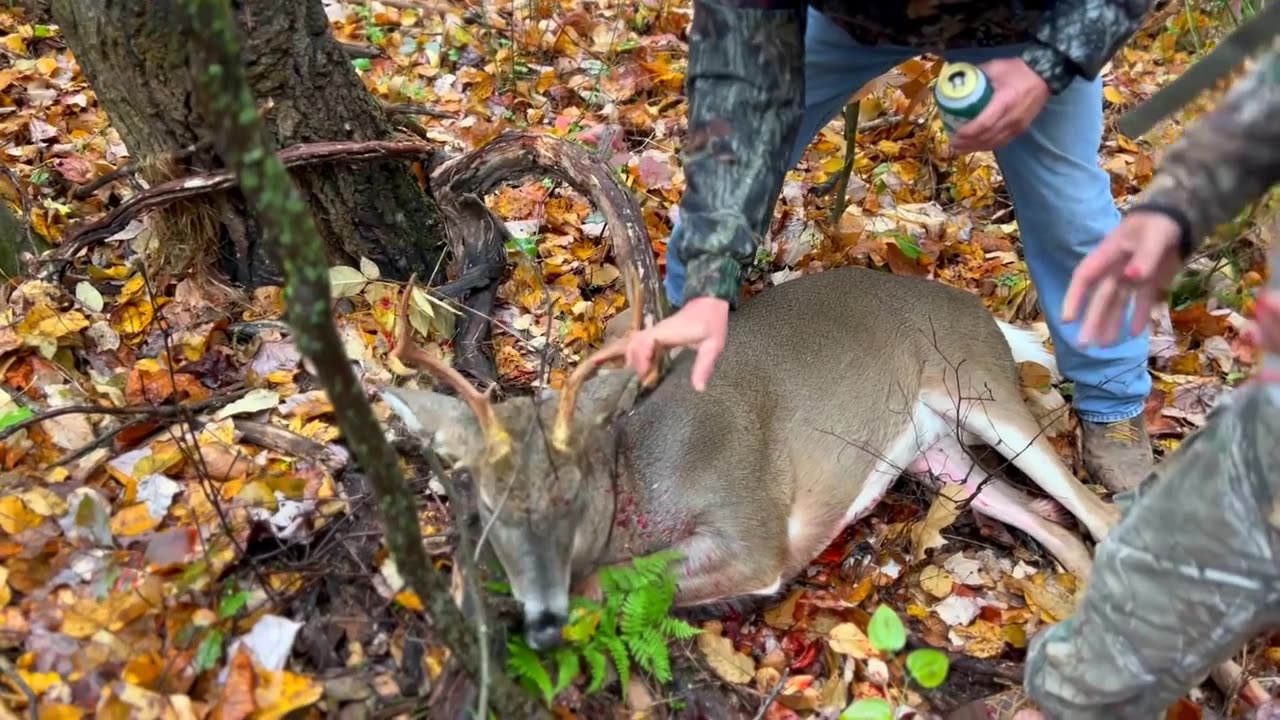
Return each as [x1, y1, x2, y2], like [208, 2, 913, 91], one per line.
[1133, 50, 1280, 252]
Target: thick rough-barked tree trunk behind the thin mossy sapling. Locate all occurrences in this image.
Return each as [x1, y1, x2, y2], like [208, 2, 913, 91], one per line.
[52, 0, 445, 287]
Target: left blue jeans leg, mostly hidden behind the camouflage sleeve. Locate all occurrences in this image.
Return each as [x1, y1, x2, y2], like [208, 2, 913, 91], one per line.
[663, 10, 916, 307]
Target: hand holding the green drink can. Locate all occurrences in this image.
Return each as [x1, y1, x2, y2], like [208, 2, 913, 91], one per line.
[951, 58, 1050, 152]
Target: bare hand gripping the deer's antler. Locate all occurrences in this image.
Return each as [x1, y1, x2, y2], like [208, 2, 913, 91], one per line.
[626, 297, 728, 392]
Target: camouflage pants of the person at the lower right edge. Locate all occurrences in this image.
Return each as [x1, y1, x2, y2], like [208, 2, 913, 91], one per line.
[1025, 383, 1280, 720]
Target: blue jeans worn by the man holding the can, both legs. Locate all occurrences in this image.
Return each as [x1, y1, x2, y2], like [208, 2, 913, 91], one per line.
[666, 10, 1151, 423]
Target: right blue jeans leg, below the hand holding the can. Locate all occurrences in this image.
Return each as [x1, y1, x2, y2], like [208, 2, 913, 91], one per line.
[948, 46, 1151, 423]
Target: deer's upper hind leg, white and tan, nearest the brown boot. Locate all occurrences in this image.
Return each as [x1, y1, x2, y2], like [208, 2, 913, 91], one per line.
[925, 392, 1120, 542]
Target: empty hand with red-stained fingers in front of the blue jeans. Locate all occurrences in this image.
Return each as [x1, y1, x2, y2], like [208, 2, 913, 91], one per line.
[1062, 210, 1181, 347]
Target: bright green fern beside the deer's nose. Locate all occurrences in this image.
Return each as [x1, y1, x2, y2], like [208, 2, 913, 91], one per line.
[507, 551, 700, 705]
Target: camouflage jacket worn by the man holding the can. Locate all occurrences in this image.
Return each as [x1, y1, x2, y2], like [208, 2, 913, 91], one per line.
[676, 0, 1151, 302]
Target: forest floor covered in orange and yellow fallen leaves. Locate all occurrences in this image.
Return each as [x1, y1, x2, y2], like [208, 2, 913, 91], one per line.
[0, 0, 1280, 720]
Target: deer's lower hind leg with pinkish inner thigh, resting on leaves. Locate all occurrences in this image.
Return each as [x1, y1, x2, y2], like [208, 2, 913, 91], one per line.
[908, 434, 1093, 580]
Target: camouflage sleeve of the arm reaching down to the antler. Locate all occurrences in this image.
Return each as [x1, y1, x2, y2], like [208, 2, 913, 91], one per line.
[677, 0, 805, 304]
